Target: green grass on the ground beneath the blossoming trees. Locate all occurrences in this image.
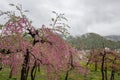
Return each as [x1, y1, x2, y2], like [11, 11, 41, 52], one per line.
[0, 68, 120, 80]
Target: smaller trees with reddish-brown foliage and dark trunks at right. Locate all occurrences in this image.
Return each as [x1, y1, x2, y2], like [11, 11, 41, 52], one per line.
[86, 49, 120, 80]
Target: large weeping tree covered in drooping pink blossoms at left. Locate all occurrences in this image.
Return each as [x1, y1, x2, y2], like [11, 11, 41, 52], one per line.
[0, 4, 86, 80]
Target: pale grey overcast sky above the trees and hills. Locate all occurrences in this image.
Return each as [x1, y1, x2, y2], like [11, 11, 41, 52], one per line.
[0, 0, 120, 35]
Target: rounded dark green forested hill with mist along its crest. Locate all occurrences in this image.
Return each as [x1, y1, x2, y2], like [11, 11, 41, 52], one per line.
[67, 33, 120, 49]
